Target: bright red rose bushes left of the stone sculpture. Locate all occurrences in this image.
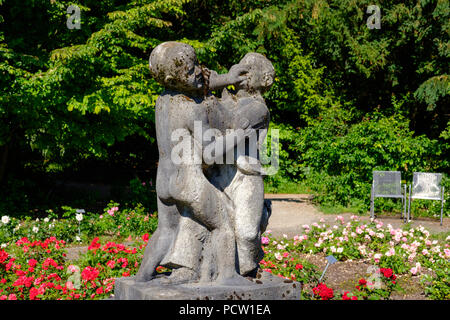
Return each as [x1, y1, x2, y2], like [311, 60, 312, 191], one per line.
[0, 234, 149, 300]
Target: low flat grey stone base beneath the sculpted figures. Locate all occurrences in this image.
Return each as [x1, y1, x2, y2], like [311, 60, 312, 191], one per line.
[114, 272, 302, 300]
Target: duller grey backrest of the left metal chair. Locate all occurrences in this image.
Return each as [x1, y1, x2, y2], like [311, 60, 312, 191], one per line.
[373, 171, 402, 197]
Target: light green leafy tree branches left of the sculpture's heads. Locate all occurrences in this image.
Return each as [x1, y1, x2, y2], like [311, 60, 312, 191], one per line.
[0, 1, 190, 178]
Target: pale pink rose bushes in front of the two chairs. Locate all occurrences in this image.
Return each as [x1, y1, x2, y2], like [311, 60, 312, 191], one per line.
[292, 216, 450, 274]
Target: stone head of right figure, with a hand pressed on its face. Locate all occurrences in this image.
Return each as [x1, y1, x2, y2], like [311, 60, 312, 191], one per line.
[234, 52, 275, 93]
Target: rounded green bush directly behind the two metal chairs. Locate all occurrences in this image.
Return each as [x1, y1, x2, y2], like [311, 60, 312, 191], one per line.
[294, 109, 448, 211]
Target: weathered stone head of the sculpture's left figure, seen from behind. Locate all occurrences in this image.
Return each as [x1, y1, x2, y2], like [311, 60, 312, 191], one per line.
[149, 41, 203, 92]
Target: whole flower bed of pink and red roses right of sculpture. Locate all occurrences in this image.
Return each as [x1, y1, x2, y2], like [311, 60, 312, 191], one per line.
[261, 216, 450, 299]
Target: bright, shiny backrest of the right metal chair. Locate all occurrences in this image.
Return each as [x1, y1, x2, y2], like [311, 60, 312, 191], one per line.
[411, 172, 442, 200]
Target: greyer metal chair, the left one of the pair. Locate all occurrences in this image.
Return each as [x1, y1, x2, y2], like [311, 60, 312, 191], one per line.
[370, 171, 406, 219]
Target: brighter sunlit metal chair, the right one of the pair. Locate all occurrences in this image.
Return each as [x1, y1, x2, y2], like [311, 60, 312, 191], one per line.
[408, 172, 445, 226]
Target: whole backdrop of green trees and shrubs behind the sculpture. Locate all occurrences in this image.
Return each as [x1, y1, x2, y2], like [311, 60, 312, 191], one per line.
[0, 0, 450, 216]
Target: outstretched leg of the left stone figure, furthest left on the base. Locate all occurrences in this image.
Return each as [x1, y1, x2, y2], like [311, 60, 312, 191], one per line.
[135, 198, 180, 282]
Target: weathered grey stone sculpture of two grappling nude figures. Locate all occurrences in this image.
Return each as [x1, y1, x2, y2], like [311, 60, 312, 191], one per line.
[116, 42, 295, 298]
